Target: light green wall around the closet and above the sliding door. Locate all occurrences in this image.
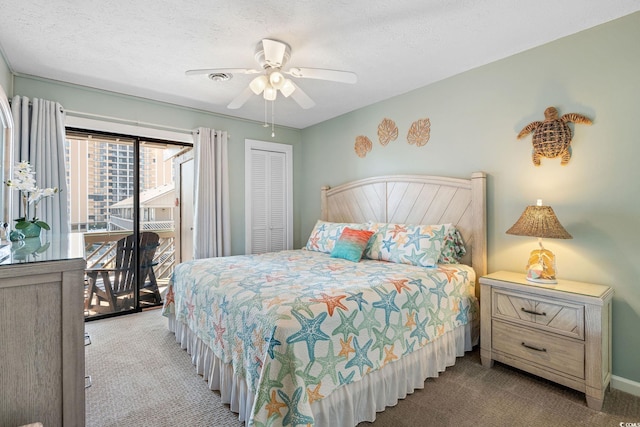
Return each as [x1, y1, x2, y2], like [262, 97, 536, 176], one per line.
[14, 76, 303, 255]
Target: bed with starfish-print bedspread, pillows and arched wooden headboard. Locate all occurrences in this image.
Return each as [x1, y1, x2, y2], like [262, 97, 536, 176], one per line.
[163, 172, 486, 426]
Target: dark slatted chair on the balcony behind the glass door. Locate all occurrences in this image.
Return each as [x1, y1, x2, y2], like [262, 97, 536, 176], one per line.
[85, 231, 161, 313]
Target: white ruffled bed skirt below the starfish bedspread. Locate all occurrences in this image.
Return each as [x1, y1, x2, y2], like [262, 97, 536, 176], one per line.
[168, 314, 479, 427]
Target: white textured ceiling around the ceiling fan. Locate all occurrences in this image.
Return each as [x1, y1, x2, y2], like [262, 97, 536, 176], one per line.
[0, 0, 640, 128]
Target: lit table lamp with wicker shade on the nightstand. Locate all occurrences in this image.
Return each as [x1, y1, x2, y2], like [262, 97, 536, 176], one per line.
[507, 199, 573, 284]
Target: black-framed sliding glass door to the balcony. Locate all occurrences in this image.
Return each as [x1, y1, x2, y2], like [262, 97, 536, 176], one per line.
[67, 129, 190, 318]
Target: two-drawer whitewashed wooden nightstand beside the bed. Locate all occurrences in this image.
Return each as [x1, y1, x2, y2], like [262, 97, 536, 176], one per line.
[480, 271, 613, 411]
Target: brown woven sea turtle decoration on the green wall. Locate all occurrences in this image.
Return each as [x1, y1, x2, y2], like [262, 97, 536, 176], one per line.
[518, 107, 592, 166]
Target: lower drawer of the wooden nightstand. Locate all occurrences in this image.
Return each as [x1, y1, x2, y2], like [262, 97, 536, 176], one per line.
[492, 320, 584, 378]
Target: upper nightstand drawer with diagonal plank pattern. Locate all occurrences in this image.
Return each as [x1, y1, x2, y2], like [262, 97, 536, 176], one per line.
[492, 289, 584, 340]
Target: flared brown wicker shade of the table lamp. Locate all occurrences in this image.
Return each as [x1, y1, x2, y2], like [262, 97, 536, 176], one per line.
[507, 206, 573, 239]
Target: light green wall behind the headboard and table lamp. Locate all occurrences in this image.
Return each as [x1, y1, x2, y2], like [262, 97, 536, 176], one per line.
[298, 13, 640, 382]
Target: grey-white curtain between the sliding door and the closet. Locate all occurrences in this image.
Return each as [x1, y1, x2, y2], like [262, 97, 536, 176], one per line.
[193, 127, 231, 259]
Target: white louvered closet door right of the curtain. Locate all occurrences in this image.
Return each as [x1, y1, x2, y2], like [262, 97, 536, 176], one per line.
[245, 141, 293, 254]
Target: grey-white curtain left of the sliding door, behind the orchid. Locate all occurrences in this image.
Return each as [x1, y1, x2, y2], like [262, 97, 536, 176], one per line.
[11, 96, 71, 234]
